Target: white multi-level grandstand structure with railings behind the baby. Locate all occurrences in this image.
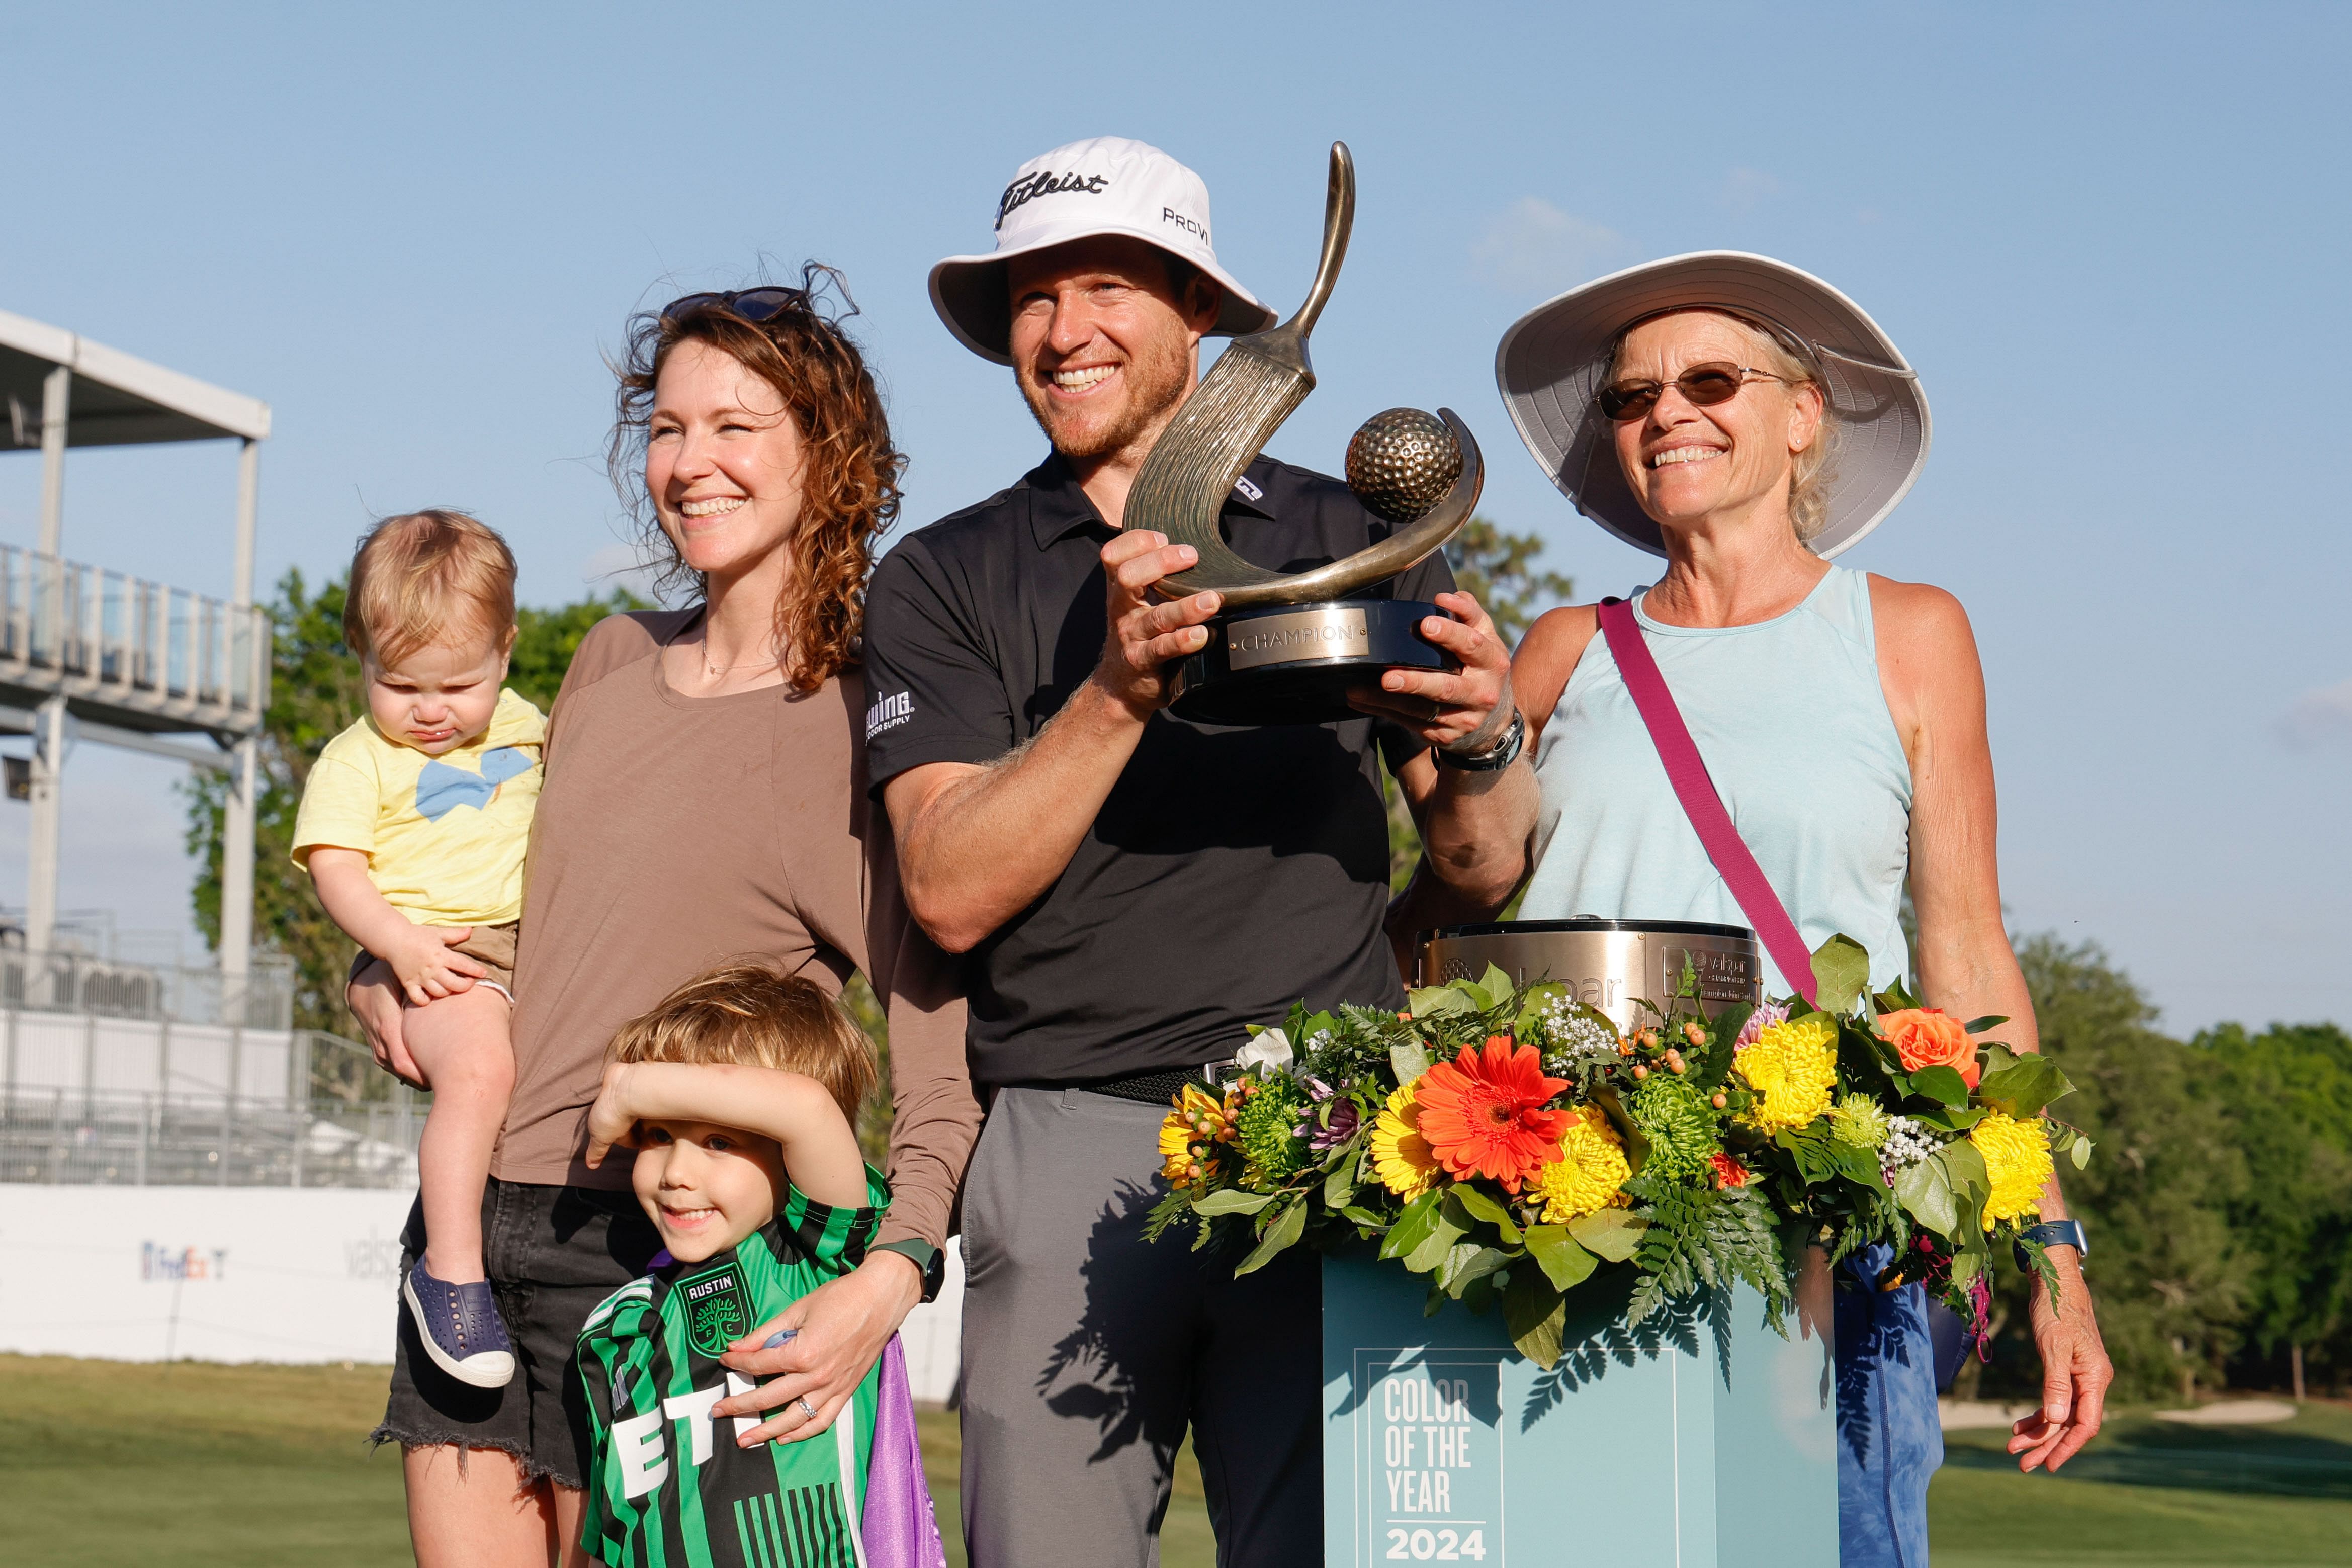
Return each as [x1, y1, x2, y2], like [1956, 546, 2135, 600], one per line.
[0, 313, 421, 1185]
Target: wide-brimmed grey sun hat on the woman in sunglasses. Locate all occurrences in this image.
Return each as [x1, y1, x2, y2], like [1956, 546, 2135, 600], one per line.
[1494, 251, 1929, 557]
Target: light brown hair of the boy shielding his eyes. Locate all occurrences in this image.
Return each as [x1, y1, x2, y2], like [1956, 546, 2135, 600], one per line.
[604, 959, 880, 1126]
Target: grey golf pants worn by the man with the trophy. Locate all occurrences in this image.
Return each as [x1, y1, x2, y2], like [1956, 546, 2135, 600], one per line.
[962, 1088, 1322, 1568]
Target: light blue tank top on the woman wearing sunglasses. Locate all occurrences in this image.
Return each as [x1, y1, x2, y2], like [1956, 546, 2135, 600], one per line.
[1519, 567, 1912, 994]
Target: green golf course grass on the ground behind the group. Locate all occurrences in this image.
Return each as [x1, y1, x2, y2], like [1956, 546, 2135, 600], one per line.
[0, 1354, 2352, 1568]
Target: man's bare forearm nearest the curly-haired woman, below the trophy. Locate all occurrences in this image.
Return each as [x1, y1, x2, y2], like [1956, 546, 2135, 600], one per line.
[899, 682, 1150, 952]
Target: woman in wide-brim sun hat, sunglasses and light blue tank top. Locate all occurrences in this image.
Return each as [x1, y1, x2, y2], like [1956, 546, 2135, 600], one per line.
[1496, 251, 2112, 1568]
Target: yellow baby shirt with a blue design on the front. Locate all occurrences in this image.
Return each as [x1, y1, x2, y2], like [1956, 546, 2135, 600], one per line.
[294, 691, 548, 926]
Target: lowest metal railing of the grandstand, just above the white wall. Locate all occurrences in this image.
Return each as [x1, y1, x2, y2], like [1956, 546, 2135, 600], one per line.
[0, 1032, 430, 1187]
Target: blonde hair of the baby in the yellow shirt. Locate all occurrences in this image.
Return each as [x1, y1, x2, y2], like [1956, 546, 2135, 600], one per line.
[343, 508, 515, 670]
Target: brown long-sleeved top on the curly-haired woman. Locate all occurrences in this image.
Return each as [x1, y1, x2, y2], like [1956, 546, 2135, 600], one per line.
[491, 609, 981, 1246]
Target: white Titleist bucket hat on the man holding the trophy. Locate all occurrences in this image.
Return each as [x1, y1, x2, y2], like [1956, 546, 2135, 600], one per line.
[931, 136, 1275, 365]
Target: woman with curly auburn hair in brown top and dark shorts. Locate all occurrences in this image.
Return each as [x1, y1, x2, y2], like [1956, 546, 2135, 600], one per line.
[351, 268, 979, 1568]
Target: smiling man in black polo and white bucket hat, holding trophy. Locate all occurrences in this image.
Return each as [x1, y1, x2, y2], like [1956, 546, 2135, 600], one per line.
[846, 136, 1533, 1568]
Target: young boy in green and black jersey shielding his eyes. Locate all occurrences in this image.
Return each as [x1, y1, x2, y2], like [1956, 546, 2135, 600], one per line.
[579, 964, 943, 1568]
